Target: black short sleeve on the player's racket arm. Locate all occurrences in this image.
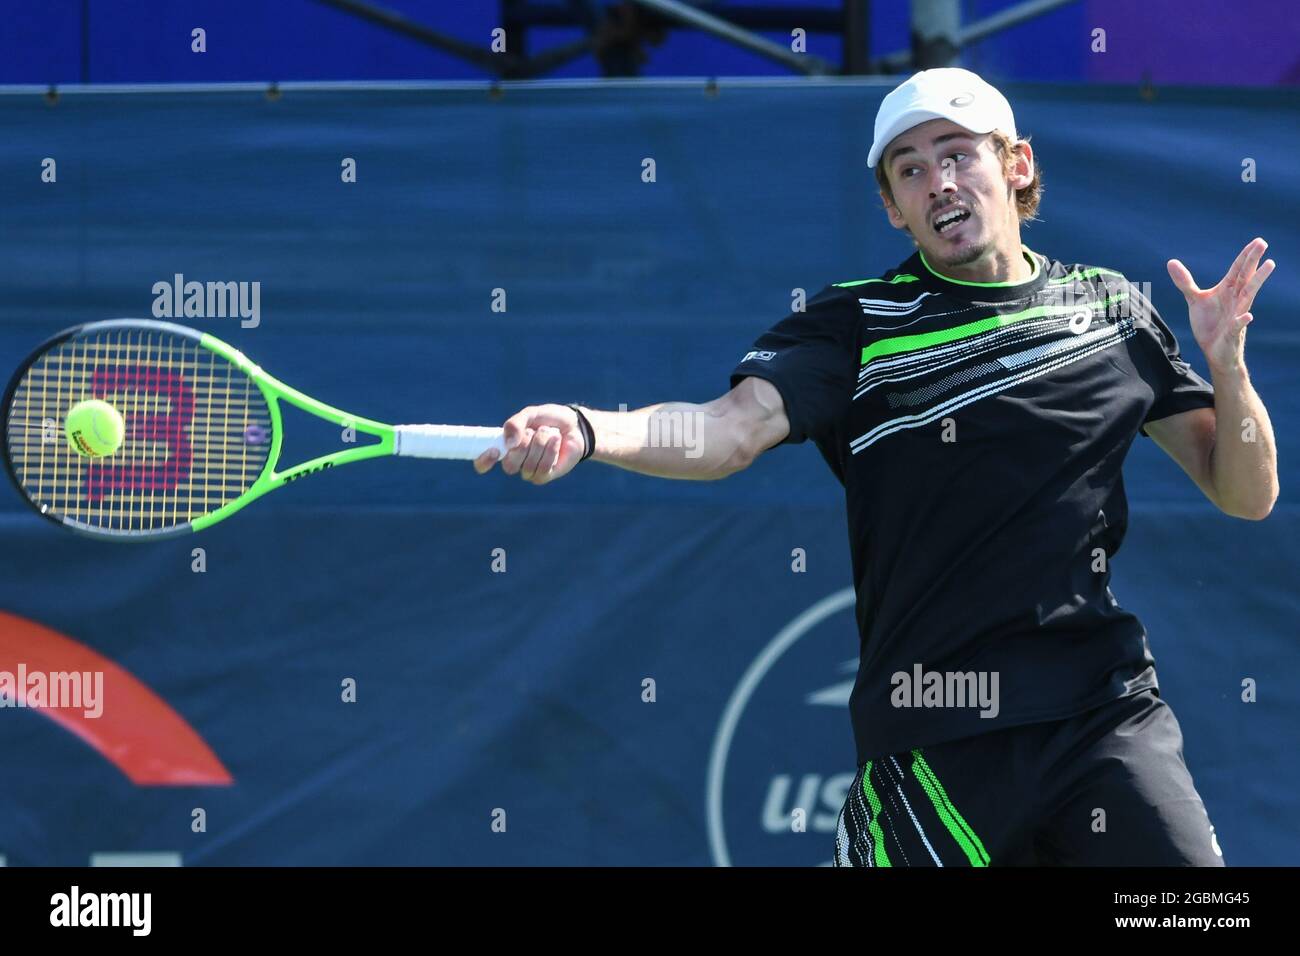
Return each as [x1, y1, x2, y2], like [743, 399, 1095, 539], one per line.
[731, 286, 857, 445]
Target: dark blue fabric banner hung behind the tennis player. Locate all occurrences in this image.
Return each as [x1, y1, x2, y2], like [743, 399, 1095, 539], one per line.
[0, 81, 1300, 865]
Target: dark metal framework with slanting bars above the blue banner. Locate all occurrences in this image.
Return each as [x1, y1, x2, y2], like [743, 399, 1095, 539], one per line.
[317, 0, 1075, 79]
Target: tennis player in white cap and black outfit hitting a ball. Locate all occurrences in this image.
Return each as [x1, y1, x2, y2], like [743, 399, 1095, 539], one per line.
[475, 69, 1278, 866]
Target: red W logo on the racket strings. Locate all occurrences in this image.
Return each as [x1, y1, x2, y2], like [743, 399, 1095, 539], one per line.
[86, 365, 194, 502]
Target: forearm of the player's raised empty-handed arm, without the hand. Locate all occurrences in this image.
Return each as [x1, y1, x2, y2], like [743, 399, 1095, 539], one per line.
[1209, 363, 1278, 519]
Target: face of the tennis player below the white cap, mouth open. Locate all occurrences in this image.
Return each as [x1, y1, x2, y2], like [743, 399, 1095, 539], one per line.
[880, 120, 1032, 269]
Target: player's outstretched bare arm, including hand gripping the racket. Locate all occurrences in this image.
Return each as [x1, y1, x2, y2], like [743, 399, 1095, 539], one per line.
[475, 376, 790, 485]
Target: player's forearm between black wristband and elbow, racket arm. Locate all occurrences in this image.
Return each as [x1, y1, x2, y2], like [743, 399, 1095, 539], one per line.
[582, 402, 748, 480]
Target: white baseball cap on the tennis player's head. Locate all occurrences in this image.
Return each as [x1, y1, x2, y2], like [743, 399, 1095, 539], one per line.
[867, 66, 1019, 166]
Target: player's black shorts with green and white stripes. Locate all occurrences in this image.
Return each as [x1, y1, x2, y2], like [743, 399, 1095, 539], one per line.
[835, 689, 1223, 866]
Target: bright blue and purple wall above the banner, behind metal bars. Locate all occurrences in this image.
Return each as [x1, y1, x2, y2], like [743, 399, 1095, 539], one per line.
[10, 0, 1300, 87]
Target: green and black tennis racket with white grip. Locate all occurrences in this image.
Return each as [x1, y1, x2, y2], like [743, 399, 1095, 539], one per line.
[0, 319, 504, 541]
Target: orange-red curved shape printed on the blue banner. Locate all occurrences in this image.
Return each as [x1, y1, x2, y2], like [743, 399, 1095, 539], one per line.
[0, 611, 234, 787]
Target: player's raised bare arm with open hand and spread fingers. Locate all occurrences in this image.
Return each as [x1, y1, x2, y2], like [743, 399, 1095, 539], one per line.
[1147, 239, 1278, 520]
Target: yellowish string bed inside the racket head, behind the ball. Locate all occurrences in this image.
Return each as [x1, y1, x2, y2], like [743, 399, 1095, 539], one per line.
[7, 328, 272, 533]
